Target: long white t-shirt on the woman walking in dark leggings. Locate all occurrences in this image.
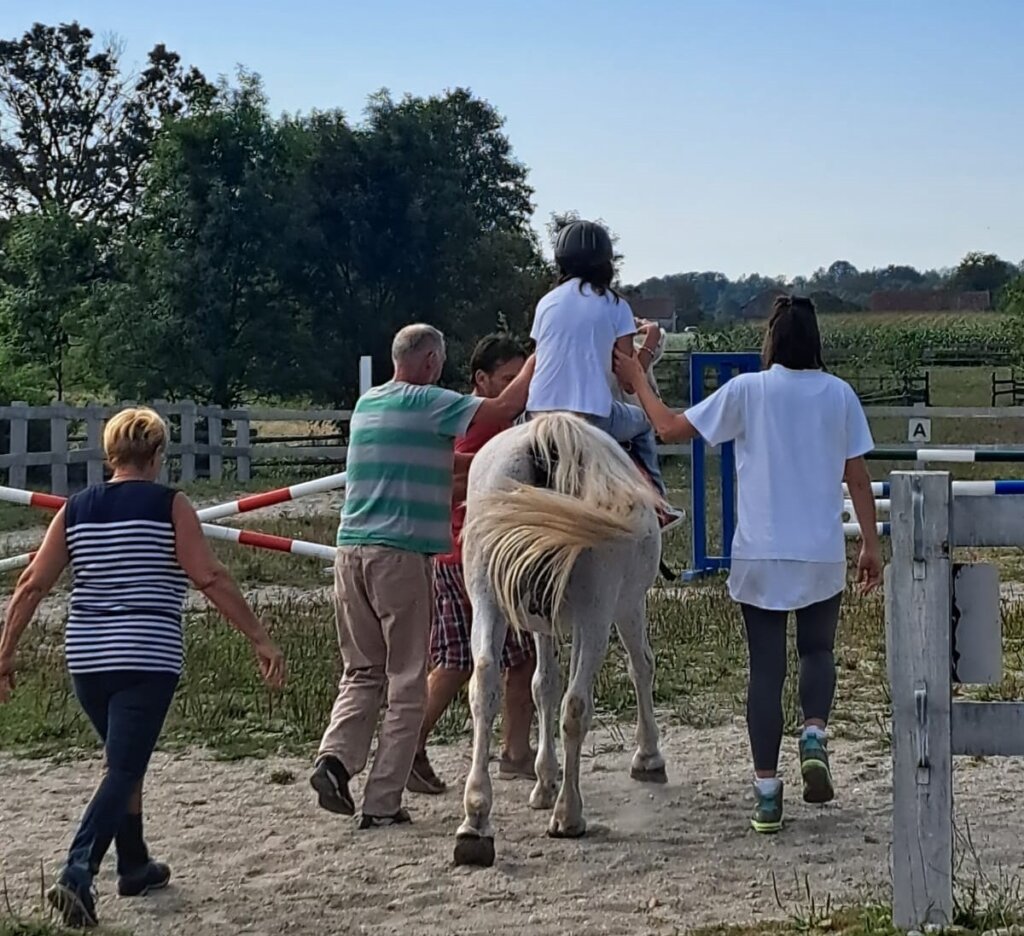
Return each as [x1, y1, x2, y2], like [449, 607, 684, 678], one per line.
[686, 365, 874, 610]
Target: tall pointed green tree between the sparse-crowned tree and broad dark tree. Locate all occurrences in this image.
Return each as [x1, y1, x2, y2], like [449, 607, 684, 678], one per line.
[94, 73, 301, 407]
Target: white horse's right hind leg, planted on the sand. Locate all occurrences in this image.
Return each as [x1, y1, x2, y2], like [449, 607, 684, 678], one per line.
[548, 615, 611, 839]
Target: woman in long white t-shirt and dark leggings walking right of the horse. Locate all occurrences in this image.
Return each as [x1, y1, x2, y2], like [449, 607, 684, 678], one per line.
[615, 297, 882, 833]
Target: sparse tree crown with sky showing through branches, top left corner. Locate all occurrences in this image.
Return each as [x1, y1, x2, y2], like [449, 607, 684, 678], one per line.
[0, 23, 212, 220]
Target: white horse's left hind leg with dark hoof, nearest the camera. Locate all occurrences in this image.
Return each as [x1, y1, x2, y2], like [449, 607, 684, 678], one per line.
[455, 594, 508, 867]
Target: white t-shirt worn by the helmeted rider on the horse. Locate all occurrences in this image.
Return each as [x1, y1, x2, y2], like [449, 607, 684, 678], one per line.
[526, 280, 637, 417]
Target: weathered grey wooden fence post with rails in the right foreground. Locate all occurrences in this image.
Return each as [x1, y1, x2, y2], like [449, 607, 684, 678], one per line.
[885, 471, 1024, 928]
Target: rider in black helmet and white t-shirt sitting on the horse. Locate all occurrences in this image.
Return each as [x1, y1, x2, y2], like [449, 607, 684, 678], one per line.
[526, 214, 682, 529]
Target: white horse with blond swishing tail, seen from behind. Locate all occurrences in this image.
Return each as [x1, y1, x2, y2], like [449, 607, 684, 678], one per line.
[455, 413, 667, 866]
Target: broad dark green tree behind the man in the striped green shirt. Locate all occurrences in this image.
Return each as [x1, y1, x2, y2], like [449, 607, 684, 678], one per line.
[283, 89, 547, 403]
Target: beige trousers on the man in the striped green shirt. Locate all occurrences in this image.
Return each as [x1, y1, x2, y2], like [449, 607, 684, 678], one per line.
[319, 546, 433, 816]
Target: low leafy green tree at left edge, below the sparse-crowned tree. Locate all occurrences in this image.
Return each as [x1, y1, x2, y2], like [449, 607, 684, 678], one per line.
[0, 211, 105, 399]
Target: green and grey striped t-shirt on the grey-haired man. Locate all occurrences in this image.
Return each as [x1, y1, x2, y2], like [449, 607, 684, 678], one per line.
[338, 380, 482, 555]
